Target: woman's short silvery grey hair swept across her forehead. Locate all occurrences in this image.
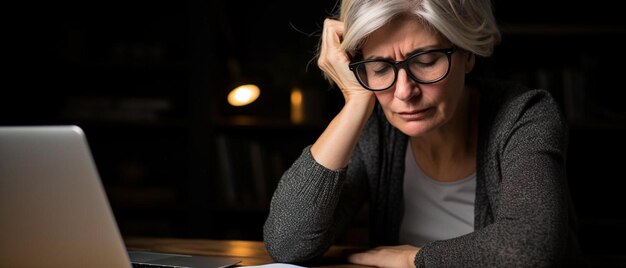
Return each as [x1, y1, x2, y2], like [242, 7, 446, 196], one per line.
[339, 0, 501, 57]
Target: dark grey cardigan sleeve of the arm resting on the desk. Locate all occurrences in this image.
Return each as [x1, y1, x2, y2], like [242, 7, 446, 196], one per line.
[415, 90, 567, 267]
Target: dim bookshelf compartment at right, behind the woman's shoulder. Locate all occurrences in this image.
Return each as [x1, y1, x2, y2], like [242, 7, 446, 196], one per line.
[494, 25, 626, 128]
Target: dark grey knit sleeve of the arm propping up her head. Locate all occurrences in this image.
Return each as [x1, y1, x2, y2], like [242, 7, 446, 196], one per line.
[263, 146, 367, 263]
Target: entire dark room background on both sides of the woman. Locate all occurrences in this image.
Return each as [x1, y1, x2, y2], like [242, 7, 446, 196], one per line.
[0, 0, 626, 266]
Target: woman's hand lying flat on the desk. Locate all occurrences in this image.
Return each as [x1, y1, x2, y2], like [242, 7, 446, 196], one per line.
[348, 245, 420, 267]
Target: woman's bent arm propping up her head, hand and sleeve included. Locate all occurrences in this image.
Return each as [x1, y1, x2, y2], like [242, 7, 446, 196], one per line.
[264, 20, 375, 262]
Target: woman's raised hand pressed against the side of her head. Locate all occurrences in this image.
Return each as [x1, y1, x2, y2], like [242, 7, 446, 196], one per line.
[317, 19, 374, 102]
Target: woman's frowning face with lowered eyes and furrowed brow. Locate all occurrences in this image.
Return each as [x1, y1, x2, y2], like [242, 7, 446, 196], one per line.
[362, 16, 473, 137]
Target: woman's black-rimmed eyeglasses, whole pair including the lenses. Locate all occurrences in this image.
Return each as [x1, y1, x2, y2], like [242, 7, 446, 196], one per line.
[348, 46, 457, 91]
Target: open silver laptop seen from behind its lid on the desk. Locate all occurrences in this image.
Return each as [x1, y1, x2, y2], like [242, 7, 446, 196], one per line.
[0, 125, 240, 268]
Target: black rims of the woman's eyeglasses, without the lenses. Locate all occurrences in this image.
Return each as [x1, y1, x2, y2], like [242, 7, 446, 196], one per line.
[348, 45, 458, 91]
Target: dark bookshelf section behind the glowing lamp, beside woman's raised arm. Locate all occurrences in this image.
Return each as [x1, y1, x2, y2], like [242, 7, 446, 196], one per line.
[195, 1, 342, 240]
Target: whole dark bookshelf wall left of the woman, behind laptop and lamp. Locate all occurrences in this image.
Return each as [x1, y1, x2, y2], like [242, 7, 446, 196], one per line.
[0, 0, 334, 239]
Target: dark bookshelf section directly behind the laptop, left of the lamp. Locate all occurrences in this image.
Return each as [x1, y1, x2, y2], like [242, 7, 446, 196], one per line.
[0, 0, 215, 237]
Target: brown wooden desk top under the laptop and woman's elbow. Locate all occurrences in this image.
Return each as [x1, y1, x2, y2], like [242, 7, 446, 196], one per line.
[124, 237, 363, 267]
